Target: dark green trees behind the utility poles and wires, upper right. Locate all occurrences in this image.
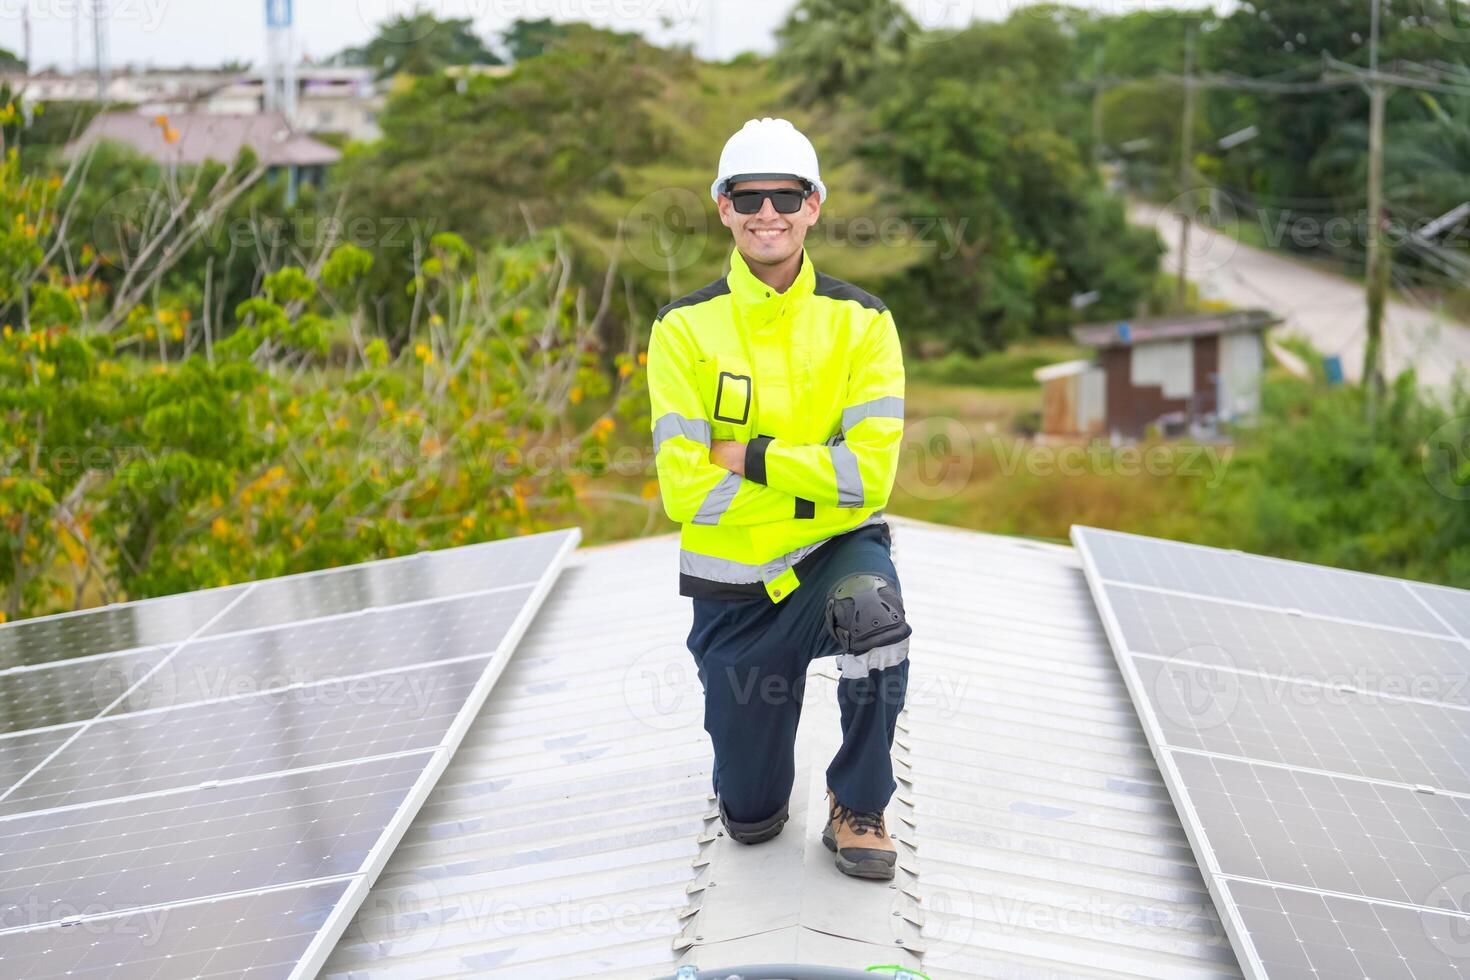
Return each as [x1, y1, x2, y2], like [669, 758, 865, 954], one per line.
[1093, 0, 1470, 287]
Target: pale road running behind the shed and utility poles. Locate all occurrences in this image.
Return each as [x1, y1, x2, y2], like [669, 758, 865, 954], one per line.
[1130, 203, 1470, 386]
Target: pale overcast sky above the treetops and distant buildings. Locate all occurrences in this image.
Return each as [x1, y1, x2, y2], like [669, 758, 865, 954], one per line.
[0, 0, 1198, 71]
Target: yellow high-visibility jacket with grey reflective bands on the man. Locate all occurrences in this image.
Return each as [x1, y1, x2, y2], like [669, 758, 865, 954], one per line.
[648, 250, 904, 602]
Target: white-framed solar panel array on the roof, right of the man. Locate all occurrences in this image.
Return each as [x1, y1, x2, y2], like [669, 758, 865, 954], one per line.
[1072, 526, 1470, 980]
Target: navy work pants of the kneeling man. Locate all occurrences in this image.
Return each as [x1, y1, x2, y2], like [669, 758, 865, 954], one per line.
[688, 525, 908, 823]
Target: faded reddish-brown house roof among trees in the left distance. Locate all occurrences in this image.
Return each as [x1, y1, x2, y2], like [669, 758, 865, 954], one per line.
[66, 112, 343, 166]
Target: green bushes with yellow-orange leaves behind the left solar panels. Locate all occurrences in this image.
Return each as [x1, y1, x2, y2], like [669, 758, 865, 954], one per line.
[0, 153, 642, 619]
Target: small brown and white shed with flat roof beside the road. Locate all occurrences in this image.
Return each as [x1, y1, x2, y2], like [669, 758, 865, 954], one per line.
[1035, 310, 1280, 441]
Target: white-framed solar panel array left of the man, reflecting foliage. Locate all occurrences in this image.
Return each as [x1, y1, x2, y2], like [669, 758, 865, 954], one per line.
[0, 529, 581, 977]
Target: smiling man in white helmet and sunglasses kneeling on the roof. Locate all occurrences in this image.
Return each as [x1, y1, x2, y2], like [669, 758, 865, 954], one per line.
[648, 118, 911, 879]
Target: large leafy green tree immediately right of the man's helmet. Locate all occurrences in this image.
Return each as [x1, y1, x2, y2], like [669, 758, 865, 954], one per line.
[866, 12, 1160, 353]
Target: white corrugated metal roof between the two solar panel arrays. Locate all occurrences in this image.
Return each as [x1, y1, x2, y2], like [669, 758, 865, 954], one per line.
[322, 519, 1241, 980]
